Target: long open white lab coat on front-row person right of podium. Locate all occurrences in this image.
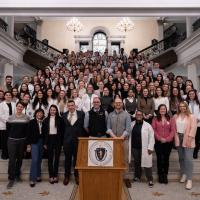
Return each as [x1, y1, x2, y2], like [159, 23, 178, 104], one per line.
[129, 121, 155, 168]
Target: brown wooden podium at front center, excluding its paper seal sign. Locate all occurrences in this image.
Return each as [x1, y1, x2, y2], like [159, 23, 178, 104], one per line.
[75, 138, 127, 200]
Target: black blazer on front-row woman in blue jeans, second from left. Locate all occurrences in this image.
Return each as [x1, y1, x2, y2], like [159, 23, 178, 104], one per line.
[27, 119, 44, 144]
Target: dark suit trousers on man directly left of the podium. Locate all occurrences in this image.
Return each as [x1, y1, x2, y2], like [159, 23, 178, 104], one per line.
[63, 141, 78, 178]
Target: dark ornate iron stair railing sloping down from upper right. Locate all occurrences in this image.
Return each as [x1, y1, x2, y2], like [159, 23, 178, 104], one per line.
[138, 32, 186, 60]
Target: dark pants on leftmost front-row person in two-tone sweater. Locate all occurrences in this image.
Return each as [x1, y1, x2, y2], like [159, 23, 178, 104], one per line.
[8, 138, 26, 180]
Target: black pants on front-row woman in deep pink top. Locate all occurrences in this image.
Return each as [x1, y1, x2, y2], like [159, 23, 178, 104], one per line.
[155, 141, 173, 175]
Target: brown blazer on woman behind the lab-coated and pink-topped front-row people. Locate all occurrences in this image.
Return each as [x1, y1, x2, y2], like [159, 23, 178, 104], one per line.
[137, 97, 155, 116]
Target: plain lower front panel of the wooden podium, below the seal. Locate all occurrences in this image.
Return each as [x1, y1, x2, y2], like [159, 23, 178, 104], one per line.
[79, 170, 122, 200]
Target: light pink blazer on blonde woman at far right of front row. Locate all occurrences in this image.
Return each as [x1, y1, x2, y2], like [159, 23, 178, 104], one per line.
[174, 114, 197, 148]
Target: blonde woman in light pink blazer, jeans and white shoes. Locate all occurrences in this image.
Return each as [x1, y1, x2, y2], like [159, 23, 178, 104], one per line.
[174, 101, 197, 190]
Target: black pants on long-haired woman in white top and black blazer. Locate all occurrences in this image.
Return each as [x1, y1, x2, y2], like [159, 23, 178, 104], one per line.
[47, 135, 61, 178]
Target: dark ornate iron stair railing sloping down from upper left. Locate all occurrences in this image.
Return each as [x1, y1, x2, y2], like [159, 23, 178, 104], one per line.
[15, 25, 62, 60]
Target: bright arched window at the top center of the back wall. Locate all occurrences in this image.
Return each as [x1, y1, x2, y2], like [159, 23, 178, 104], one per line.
[93, 32, 107, 54]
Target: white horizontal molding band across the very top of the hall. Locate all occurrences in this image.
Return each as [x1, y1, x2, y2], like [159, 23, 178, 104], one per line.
[0, 7, 200, 17]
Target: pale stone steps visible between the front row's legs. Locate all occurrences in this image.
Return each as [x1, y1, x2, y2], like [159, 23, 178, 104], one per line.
[0, 150, 200, 181]
